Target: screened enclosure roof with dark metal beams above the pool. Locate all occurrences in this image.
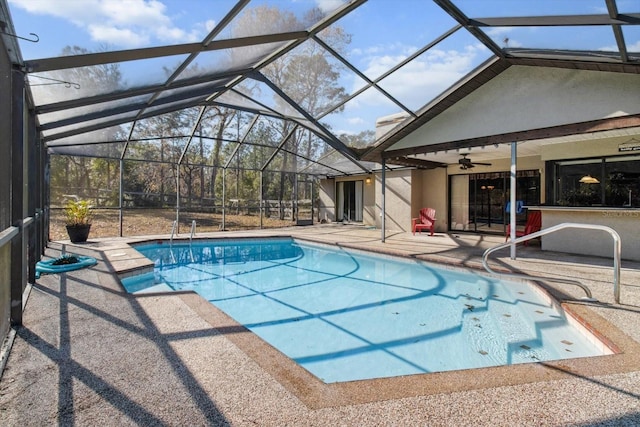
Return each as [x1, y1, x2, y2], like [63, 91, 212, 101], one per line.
[5, 0, 640, 176]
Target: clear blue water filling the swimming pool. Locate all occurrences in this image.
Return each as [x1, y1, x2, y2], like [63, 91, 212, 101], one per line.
[122, 238, 603, 383]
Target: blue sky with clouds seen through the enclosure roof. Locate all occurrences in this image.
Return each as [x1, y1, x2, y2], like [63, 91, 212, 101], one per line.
[8, 0, 640, 139]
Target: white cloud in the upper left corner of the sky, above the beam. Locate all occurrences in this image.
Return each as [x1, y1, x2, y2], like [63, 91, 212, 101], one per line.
[9, 0, 202, 48]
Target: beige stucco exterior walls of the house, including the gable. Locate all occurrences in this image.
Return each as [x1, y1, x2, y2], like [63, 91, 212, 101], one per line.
[326, 66, 640, 241]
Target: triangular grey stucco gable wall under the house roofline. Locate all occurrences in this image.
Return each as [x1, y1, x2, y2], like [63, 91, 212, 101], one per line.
[392, 66, 640, 150]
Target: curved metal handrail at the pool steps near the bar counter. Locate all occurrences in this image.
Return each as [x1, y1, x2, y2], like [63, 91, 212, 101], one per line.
[482, 222, 622, 304]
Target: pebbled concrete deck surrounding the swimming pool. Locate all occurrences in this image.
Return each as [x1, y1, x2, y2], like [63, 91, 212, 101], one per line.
[0, 225, 640, 426]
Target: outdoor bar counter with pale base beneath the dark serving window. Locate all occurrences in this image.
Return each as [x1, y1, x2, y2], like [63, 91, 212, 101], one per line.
[527, 206, 640, 261]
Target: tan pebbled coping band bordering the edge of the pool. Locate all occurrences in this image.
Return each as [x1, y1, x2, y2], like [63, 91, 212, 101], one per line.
[110, 235, 640, 409]
